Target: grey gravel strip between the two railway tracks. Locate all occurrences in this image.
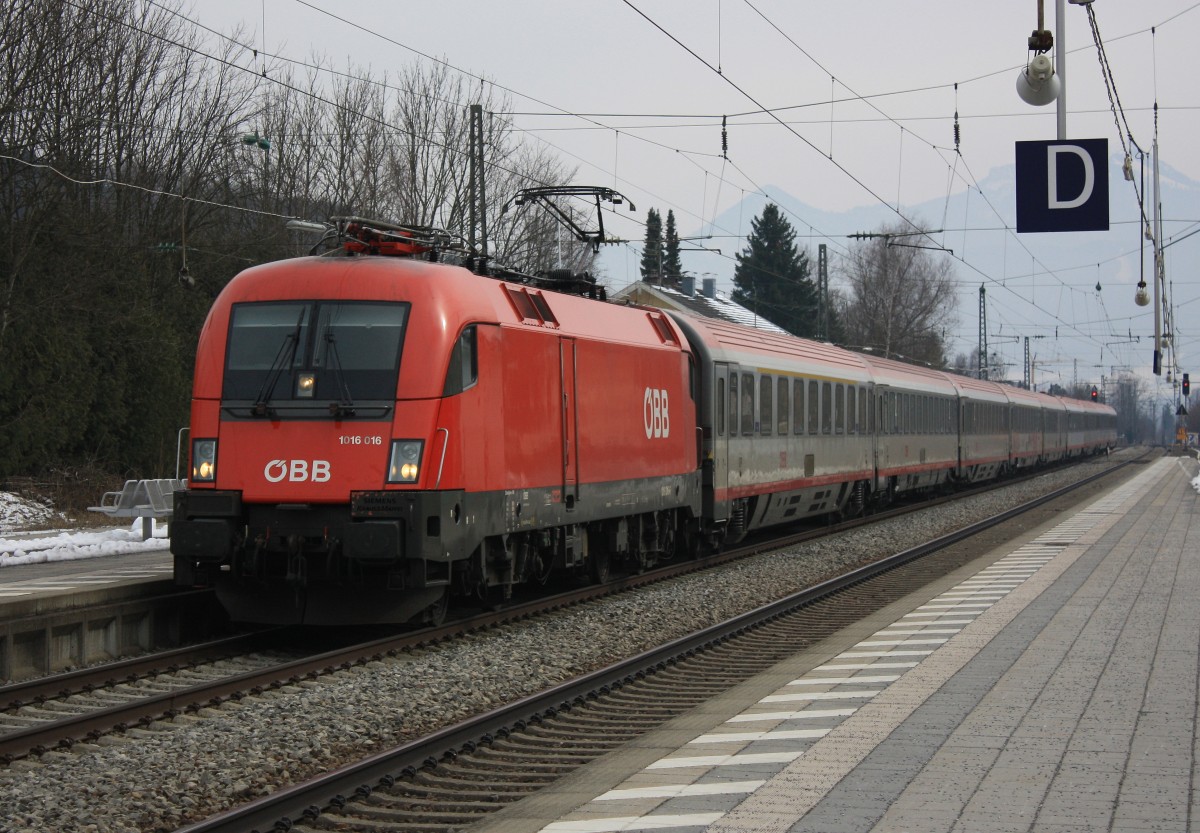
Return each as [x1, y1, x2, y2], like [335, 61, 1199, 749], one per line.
[0, 451, 1142, 833]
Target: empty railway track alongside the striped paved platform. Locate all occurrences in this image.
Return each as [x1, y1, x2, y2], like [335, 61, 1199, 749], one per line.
[164, 453, 1134, 833]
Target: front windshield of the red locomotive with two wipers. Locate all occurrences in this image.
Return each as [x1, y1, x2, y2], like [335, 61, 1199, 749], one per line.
[223, 301, 408, 415]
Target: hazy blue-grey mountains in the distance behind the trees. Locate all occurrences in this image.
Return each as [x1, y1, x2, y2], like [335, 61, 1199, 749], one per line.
[667, 156, 1200, 373]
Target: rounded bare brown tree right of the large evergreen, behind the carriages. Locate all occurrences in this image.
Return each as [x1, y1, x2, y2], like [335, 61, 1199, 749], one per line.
[839, 227, 958, 367]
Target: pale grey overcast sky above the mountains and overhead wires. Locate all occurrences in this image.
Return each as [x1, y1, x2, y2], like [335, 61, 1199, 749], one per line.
[190, 0, 1200, 403]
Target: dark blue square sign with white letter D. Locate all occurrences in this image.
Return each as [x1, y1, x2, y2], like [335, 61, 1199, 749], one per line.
[1016, 139, 1109, 232]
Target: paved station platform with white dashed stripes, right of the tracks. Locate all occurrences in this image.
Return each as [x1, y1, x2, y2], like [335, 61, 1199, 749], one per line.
[473, 457, 1200, 833]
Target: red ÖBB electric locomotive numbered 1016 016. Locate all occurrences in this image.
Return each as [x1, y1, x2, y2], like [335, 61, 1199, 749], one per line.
[170, 220, 701, 624]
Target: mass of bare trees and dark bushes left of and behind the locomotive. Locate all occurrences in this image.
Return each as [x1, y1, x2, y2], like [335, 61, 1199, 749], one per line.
[0, 0, 590, 477]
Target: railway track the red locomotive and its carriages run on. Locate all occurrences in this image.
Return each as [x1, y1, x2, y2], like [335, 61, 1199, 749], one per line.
[0, 453, 1142, 763]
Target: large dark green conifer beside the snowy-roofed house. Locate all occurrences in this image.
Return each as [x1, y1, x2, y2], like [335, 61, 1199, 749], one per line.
[733, 203, 817, 338]
